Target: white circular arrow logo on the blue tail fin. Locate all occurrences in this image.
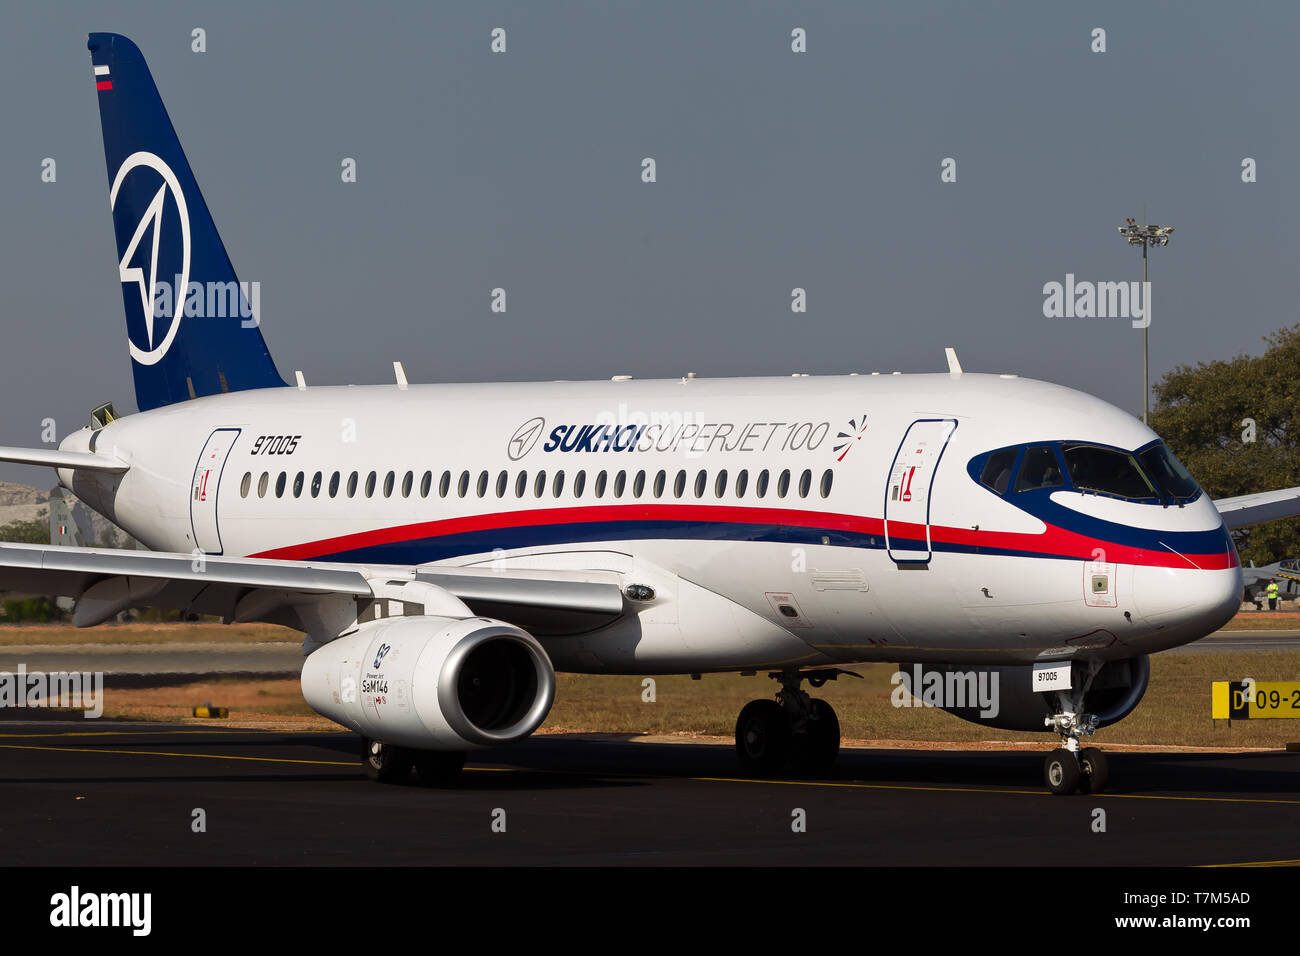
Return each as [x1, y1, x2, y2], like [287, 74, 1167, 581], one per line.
[108, 151, 190, 365]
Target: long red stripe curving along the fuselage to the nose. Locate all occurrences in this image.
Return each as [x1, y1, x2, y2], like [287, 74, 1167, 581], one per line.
[250, 505, 1238, 571]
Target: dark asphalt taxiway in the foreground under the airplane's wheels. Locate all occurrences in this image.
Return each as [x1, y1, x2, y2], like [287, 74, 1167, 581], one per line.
[0, 719, 1300, 866]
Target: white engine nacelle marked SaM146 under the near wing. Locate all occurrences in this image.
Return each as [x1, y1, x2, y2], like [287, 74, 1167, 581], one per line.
[302, 617, 555, 750]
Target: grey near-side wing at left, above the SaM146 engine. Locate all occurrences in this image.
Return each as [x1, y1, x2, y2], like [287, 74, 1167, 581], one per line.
[0, 544, 624, 640]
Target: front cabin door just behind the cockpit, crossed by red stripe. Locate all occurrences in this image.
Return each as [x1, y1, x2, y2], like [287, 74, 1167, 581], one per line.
[885, 419, 957, 564]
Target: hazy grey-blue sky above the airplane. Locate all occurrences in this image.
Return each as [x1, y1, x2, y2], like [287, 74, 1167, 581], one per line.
[0, 0, 1300, 485]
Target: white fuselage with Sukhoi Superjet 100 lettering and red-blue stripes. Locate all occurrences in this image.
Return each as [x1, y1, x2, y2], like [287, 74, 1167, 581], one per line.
[60, 375, 1242, 672]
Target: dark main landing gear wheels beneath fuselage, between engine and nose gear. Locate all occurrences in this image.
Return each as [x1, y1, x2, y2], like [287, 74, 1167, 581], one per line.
[736, 669, 859, 777]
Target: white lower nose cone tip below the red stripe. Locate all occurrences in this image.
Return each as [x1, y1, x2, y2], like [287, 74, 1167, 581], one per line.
[1134, 566, 1242, 643]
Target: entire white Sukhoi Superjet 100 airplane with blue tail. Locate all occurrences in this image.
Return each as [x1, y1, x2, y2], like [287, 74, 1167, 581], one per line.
[0, 33, 1300, 795]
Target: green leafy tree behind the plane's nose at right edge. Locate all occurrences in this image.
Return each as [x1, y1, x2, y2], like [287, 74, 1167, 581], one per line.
[1151, 325, 1300, 564]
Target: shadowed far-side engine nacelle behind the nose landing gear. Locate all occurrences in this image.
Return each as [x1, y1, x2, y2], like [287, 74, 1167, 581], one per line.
[898, 654, 1151, 731]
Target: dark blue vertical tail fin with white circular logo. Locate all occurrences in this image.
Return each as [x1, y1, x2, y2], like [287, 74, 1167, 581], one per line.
[87, 34, 285, 411]
